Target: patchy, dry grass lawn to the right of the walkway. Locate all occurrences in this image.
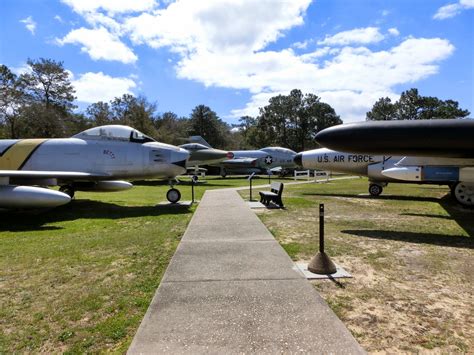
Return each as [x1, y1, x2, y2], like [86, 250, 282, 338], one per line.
[242, 178, 474, 353]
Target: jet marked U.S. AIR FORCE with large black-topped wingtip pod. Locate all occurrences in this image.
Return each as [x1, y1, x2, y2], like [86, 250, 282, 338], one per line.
[295, 119, 474, 206]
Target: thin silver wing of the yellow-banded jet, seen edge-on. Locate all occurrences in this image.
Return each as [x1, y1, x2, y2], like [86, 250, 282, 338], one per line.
[0, 170, 111, 180]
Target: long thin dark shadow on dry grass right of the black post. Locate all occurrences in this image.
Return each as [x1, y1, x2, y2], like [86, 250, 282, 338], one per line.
[341, 229, 474, 249]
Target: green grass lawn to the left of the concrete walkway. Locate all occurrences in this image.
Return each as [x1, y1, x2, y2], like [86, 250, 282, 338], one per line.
[0, 177, 267, 353]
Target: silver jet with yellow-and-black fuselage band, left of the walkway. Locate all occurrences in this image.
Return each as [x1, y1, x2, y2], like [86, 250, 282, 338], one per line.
[0, 125, 189, 209]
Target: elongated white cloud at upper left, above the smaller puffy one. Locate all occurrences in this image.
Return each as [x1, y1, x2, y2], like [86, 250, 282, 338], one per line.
[56, 27, 138, 63]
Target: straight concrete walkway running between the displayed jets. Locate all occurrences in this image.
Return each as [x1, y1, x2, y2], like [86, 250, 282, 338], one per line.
[128, 190, 364, 354]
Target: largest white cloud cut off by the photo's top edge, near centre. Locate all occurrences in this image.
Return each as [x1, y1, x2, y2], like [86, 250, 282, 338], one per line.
[125, 0, 310, 53]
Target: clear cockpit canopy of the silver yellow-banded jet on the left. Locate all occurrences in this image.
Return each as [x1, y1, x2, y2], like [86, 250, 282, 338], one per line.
[72, 125, 156, 143]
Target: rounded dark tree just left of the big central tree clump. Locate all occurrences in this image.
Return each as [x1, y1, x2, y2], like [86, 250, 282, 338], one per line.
[189, 105, 229, 148]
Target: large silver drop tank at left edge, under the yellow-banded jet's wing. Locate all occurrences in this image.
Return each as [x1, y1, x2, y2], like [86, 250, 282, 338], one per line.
[0, 185, 71, 209]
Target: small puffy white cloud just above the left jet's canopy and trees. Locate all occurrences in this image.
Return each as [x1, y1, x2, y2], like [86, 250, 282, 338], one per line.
[72, 72, 137, 103]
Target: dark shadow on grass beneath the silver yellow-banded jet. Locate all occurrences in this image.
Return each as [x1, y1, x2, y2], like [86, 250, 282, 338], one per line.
[0, 199, 190, 232]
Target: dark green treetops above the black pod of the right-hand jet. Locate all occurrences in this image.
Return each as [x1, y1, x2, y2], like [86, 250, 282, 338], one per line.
[366, 88, 469, 120]
